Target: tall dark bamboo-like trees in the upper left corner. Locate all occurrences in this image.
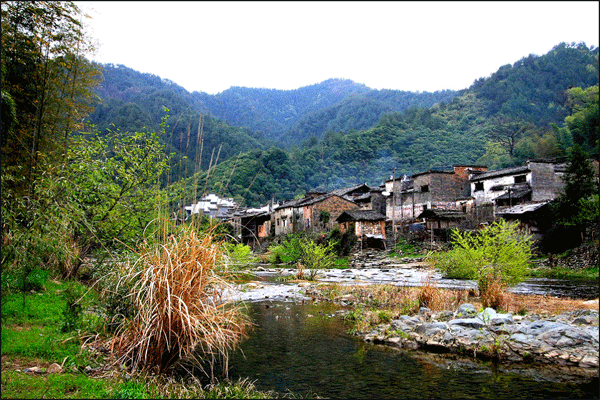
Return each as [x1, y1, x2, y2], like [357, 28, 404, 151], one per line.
[1, 1, 99, 198]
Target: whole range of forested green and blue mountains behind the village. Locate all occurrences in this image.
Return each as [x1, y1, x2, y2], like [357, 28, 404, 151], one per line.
[86, 43, 598, 205]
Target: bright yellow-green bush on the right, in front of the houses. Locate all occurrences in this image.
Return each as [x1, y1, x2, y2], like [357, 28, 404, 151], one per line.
[428, 220, 532, 290]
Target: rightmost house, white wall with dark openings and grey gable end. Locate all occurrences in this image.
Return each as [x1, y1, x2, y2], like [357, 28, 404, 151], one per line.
[470, 160, 566, 207]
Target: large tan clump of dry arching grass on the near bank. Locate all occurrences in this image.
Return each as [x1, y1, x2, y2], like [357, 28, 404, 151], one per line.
[112, 228, 248, 377]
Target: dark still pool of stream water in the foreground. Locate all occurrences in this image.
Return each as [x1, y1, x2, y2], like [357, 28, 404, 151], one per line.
[224, 300, 598, 399]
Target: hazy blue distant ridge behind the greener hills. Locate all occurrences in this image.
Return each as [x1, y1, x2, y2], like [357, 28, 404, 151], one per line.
[90, 64, 458, 146]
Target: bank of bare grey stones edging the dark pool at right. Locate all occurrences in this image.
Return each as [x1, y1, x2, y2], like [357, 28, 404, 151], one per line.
[358, 303, 598, 375]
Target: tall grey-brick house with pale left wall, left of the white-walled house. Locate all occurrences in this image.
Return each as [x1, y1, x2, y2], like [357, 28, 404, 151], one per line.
[386, 165, 487, 221]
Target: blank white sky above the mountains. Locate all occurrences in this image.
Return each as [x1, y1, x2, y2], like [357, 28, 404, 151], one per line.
[75, 1, 600, 94]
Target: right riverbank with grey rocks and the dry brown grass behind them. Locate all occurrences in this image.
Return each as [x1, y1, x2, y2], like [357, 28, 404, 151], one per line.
[307, 284, 599, 376]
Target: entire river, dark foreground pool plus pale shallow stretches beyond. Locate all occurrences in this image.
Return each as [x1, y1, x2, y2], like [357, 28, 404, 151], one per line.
[209, 266, 598, 399]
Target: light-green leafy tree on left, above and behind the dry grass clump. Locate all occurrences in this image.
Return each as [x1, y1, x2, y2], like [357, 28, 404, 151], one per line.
[67, 117, 167, 245]
